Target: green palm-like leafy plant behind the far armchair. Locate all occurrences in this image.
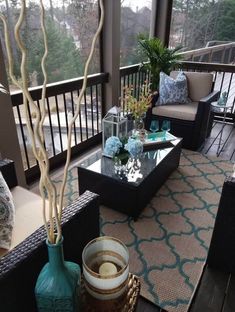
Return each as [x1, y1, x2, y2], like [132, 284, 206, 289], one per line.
[138, 35, 182, 91]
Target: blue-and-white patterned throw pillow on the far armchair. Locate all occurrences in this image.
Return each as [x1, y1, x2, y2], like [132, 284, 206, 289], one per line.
[157, 71, 190, 105]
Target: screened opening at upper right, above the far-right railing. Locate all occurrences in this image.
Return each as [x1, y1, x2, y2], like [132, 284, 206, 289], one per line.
[170, 0, 235, 61]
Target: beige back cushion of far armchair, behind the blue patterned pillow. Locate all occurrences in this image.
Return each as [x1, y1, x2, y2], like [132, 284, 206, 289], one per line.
[171, 71, 213, 102]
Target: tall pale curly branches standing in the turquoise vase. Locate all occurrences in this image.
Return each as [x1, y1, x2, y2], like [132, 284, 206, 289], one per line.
[0, 0, 104, 243]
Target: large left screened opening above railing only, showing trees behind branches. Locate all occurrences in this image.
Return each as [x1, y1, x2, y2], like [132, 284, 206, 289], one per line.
[0, 0, 100, 90]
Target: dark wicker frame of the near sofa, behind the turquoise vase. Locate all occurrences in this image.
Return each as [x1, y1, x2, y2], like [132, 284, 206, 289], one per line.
[0, 161, 99, 312]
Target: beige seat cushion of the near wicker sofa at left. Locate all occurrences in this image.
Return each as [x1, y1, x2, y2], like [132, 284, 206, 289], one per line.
[11, 186, 44, 249]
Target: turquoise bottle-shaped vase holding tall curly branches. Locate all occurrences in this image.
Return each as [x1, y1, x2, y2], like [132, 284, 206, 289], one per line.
[35, 239, 81, 312]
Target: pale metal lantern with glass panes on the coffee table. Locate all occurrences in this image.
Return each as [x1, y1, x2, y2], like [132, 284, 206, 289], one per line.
[102, 106, 127, 148]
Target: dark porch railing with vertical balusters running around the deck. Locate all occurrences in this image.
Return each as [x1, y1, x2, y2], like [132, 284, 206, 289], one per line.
[11, 61, 235, 181]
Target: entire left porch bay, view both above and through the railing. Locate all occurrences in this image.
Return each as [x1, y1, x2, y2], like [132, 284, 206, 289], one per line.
[0, 0, 102, 170]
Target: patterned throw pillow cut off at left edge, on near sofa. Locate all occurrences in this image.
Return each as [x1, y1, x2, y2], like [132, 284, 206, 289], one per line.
[0, 172, 15, 249]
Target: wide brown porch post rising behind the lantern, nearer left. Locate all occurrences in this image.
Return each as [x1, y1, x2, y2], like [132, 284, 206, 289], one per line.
[101, 0, 121, 114]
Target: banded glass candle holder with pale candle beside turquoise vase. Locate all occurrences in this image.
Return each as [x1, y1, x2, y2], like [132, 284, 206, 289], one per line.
[82, 236, 129, 300]
